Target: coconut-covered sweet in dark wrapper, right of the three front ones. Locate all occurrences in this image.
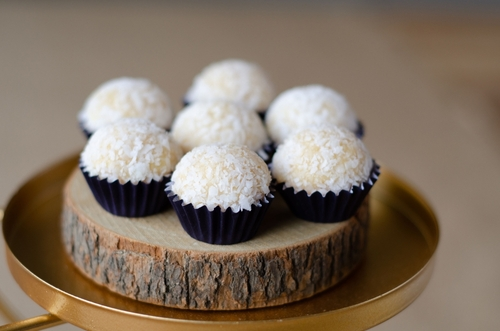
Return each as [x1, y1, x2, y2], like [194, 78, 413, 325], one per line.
[271, 127, 380, 223]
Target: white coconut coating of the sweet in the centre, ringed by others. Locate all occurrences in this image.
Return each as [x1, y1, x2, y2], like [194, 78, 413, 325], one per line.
[171, 100, 269, 153]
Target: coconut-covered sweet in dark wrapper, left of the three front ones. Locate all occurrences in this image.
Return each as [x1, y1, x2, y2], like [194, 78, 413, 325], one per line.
[80, 118, 183, 217]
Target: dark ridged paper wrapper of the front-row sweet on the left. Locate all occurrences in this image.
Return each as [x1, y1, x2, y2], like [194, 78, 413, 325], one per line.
[80, 167, 170, 217]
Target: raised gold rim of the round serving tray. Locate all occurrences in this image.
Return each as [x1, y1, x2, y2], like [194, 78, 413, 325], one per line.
[2, 155, 440, 330]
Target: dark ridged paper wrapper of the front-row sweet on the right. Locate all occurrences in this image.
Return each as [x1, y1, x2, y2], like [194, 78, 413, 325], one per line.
[276, 161, 380, 223]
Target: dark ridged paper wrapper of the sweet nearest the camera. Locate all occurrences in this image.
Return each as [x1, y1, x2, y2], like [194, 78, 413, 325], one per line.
[166, 188, 274, 245]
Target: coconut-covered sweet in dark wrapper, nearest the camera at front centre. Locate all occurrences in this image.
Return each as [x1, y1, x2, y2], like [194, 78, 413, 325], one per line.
[166, 144, 273, 245]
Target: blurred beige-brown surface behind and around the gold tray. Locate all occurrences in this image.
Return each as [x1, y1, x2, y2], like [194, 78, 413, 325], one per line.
[0, 1, 500, 330]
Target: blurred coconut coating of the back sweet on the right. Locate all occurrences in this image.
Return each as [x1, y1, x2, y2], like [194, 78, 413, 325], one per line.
[265, 85, 358, 144]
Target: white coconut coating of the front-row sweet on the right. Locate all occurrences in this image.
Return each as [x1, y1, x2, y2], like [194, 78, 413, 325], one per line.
[272, 127, 373, 196]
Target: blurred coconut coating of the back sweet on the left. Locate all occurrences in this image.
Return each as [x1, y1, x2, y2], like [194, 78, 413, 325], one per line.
[78, 77, 174, 132]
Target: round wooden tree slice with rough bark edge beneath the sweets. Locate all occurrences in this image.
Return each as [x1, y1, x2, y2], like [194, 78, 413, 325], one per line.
[62, 169, 369, 310]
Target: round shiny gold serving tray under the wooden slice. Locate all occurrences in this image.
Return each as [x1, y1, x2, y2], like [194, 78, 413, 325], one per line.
[3, 156, 439, 331]
